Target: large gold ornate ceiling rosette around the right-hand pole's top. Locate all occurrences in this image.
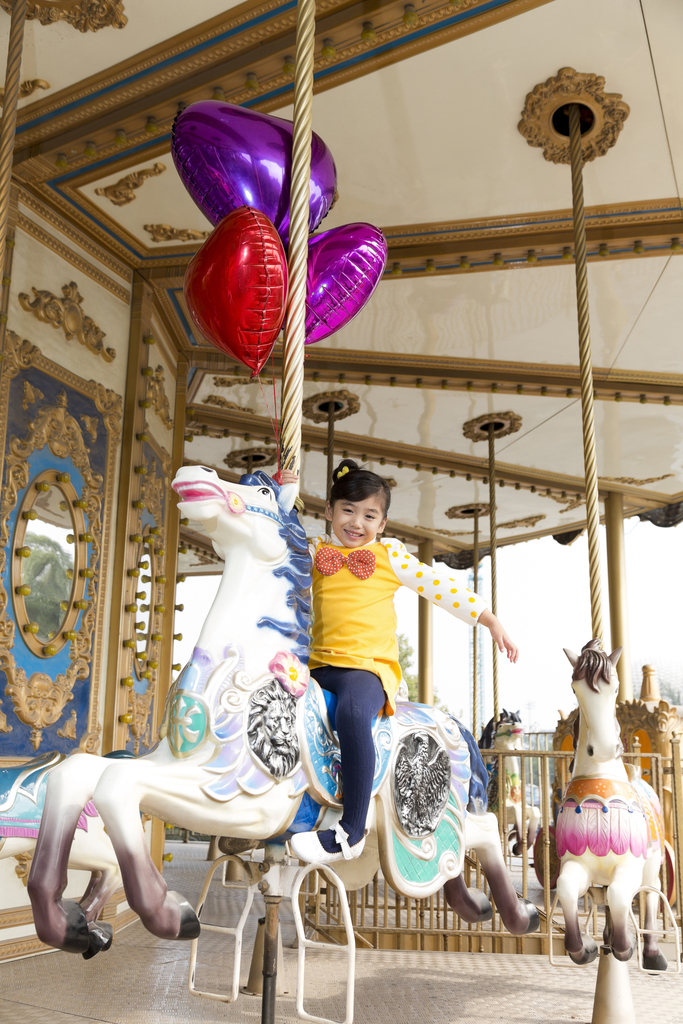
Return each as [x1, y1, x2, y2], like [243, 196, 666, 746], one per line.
[517, 68, 631, 164]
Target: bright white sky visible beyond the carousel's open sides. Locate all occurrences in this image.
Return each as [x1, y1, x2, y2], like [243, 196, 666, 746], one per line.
[174, 519, 683, 731]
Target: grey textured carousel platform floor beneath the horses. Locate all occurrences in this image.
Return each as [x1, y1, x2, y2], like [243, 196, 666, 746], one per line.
[0, 843, 683, 1024]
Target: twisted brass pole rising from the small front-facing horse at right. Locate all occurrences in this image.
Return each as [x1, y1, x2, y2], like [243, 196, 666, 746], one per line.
[569, 103, 602, 639]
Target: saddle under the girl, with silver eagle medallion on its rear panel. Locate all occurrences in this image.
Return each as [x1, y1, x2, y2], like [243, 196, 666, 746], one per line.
[290, 679, 487, 896]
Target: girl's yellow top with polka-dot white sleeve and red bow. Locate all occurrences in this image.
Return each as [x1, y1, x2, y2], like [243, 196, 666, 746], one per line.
[308, 537, 487, 715]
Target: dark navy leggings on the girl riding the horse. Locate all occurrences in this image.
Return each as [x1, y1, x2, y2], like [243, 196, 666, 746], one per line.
[311, 665, 386, 846]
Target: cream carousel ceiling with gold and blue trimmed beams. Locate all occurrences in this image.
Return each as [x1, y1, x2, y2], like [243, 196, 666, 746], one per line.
[6, 0, 683, 566]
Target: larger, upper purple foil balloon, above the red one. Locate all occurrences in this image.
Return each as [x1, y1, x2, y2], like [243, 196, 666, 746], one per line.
[172, 99, 337, 245]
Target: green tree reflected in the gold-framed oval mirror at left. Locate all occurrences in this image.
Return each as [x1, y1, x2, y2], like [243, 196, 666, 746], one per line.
[22, 534, 74, 639]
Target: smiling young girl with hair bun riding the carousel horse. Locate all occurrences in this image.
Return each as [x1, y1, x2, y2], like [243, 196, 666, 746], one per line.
[283, 459, 517, 863]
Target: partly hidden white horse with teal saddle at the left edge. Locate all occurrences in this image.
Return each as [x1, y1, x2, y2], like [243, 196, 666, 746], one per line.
[0, 751, 121, 958]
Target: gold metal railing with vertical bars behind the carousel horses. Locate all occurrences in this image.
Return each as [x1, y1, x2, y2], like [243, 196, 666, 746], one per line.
[300, 734, 683, 956]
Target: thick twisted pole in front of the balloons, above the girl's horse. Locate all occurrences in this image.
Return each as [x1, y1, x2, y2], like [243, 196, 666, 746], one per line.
[281, 0, 315, 472]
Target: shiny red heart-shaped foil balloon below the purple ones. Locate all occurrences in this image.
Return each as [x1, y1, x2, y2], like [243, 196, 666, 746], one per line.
[183, 206, 287, 374]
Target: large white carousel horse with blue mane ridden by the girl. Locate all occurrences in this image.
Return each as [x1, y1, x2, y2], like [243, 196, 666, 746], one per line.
[29, 466, 539, 951]
